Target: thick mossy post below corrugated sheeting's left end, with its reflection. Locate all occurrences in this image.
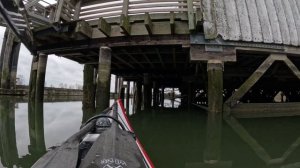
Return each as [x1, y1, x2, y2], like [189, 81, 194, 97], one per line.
[204, 60, 223, 163]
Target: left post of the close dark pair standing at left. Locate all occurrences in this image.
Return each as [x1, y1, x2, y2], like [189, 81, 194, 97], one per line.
[28, 56, 38, 100]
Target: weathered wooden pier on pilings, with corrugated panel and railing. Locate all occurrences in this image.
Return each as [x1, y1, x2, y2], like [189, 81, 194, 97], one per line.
[0, 0, 300, 117]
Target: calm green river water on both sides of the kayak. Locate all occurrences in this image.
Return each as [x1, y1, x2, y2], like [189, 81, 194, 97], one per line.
[0, 97, 300, 168]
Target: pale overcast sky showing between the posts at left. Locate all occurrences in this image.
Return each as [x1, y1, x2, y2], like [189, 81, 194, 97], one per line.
[0, 27, 83, 86]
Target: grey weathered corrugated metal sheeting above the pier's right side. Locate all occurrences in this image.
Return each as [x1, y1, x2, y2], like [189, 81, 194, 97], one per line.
[203, 0, 300, 46]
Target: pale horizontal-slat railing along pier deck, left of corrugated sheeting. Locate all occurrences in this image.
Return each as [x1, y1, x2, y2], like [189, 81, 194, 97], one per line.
[79, 0, 201, 20]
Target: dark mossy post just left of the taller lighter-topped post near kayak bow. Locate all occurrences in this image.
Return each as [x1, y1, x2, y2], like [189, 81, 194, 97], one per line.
[82, 64, 95, 109]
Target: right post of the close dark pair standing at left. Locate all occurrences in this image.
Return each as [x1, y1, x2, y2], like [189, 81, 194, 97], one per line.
[35, 53, 48, 103]
